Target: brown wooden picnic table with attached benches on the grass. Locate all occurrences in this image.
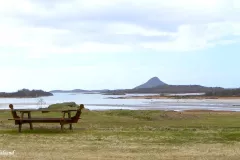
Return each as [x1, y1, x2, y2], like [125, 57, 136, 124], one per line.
[8, 104, 84, 132]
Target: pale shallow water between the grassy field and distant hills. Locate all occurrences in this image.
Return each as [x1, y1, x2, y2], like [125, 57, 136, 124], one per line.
[0, 93, 240, 111]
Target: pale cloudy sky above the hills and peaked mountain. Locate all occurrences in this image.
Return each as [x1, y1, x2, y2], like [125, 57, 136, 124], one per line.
[0, 0, 240, 91]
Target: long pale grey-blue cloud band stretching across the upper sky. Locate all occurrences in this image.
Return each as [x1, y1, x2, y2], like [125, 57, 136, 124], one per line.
[18, 0, 227, 32]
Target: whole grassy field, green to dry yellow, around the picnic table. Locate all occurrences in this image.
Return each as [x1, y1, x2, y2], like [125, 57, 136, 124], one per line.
[0, 106, 240, 160]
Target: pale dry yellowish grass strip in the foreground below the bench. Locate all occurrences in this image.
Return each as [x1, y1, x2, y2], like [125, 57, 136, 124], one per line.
[1, 133, 240, 160]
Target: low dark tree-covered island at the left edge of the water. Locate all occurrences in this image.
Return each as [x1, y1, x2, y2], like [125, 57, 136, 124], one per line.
[0, 89, 53, 98]
